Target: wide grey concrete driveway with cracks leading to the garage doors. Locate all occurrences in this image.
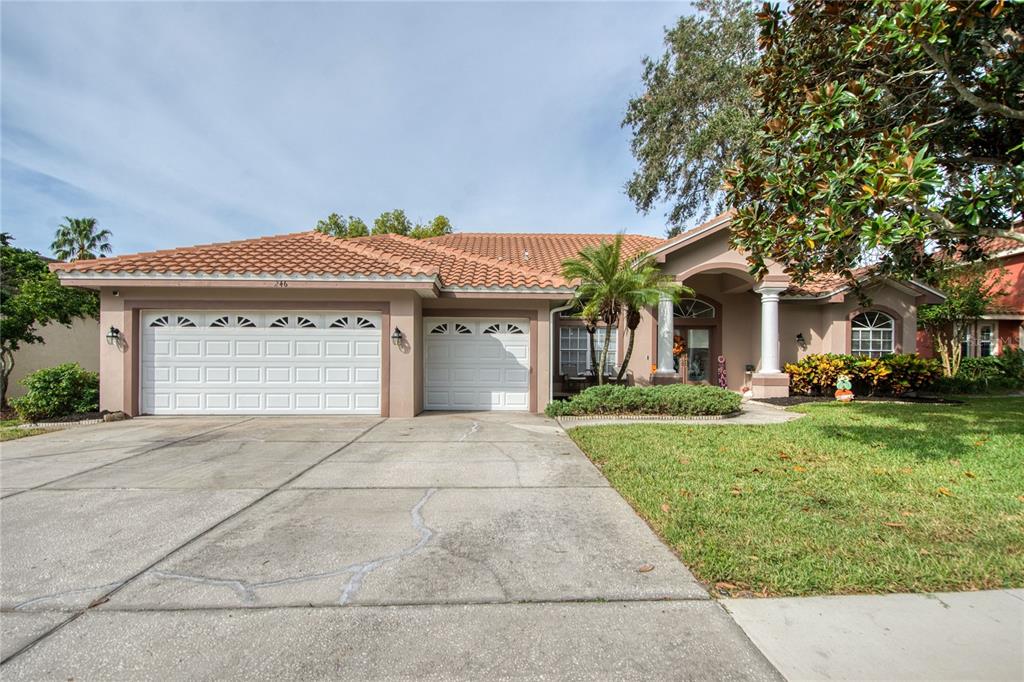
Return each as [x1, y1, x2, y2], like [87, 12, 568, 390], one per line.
[0, 413, 777, 680]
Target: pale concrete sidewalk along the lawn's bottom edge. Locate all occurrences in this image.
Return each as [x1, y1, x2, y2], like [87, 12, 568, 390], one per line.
[723, 590, 1024, 680]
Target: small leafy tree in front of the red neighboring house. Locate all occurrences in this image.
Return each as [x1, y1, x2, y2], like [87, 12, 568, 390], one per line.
[918, 262, 1006, 377]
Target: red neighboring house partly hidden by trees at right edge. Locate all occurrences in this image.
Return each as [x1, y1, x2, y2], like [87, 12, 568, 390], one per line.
[918, 223, 1024, 357]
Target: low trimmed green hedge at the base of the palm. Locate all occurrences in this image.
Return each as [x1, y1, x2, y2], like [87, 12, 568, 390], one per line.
[545, 384, 740, 417]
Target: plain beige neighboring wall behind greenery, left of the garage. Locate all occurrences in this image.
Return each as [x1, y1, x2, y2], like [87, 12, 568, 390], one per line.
[7, 317, 100, 398]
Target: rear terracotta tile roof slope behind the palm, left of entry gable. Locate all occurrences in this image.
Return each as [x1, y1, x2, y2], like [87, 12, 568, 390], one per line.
[426, 232, 665, 274]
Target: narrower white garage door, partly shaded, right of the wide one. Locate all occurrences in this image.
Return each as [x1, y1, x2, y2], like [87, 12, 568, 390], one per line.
[423, 317, 530, 410]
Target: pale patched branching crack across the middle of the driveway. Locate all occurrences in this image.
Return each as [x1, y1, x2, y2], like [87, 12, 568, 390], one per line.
[151, 487, 437, 606]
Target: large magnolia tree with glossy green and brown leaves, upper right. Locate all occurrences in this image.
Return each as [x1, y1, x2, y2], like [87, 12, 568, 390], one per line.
[726, 0, 1024, 281]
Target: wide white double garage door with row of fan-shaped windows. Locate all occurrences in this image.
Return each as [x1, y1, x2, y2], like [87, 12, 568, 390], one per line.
[141, 310, 381, 415]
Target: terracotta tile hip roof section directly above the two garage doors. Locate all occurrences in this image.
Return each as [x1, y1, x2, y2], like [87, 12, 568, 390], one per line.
[51, 231, 567, 288]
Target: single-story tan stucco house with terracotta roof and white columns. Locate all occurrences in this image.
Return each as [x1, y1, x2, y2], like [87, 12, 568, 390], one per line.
[52, 214, 937, 417]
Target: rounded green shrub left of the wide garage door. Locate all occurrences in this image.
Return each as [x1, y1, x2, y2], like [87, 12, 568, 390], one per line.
[11, 363, 99, 422]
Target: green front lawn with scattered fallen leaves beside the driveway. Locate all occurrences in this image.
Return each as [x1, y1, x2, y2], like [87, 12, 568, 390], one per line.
[570, 398, 1024, 595]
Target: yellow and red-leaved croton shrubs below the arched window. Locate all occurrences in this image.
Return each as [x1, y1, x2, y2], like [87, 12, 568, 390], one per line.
[785, 353, 942, 395]
